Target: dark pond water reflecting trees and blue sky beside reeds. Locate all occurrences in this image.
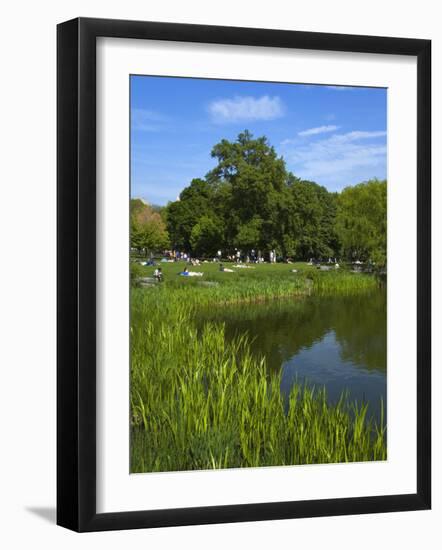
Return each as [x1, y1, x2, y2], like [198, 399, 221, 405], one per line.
[198, 289, 387, 420]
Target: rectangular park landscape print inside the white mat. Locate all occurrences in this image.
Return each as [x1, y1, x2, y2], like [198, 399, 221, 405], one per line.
[128, 74, 387, 473]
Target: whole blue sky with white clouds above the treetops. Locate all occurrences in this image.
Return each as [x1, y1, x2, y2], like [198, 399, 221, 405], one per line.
[131, 76, 387, 205]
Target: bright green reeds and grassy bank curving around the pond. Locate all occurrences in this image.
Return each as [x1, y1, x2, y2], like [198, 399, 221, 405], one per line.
[131, 264, 386, 472]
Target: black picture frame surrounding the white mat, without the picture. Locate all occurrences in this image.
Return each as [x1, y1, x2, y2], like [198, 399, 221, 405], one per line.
[57, 18, 431, 532]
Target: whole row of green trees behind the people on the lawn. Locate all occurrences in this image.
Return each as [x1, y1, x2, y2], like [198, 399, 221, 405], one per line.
[131, 130, 387, 266]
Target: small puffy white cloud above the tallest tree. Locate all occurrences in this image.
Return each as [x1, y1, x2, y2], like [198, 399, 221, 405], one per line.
[209, 95, 284, 123]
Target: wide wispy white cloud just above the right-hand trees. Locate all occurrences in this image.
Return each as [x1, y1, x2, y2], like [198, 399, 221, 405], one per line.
[281, 131, 387, 185]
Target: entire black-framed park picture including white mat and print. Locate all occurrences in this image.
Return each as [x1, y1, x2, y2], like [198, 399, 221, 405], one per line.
[57, 18, 431, 531]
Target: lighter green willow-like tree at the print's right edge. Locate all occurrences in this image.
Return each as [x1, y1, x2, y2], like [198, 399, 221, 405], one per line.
[336, 180, 387, 266]
